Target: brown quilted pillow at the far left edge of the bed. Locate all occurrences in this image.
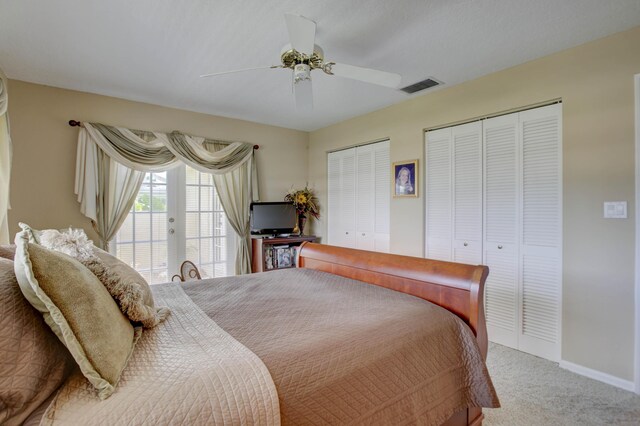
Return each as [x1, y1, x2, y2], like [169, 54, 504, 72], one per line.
[0, 256, 74, 425]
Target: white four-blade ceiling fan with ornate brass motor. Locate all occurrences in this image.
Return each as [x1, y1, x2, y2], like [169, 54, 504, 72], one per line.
[200, 13, 401, 109]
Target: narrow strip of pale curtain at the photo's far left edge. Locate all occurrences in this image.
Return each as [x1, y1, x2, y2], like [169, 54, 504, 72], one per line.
[0, 69, 11, 244]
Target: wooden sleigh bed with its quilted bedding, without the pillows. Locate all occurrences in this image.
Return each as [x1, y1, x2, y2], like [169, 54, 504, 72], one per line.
[0, 243, 499, 425]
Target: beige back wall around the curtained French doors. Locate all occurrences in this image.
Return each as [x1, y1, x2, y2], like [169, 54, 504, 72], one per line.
[9, 80, 308, 243]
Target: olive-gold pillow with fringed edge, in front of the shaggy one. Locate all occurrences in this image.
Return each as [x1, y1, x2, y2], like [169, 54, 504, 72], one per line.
[14, 231, 140, 399]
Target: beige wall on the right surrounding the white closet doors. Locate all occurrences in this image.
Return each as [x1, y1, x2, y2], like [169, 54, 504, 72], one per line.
[309, 27, 640, 381]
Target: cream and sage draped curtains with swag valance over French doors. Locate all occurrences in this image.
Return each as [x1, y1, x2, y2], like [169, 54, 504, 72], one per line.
[75, 123, 258, 274]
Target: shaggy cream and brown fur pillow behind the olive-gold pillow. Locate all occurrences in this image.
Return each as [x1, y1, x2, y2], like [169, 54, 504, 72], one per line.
[40, 228, 170, 328]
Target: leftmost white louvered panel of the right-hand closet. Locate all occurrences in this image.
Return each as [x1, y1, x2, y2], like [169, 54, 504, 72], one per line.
[425, 128, 452, 261]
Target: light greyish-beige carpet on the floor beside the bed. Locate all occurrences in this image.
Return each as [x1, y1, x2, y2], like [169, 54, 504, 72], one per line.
[483, 343, 640, 426]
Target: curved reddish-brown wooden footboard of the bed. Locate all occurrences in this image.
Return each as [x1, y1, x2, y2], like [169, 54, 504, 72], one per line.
[298, 242, 489, 426]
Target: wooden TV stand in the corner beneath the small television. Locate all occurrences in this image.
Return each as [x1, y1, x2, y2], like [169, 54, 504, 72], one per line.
[251, 235, 318, 272]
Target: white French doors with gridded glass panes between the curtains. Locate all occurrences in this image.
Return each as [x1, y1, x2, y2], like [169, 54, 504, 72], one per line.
[111, 166, 235, 284]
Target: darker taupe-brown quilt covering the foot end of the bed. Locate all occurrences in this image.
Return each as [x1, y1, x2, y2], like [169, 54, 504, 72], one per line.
[184, 269, 499, 425]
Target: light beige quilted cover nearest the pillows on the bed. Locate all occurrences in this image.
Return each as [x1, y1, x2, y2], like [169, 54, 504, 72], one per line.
[41, 283, 280, 425]
